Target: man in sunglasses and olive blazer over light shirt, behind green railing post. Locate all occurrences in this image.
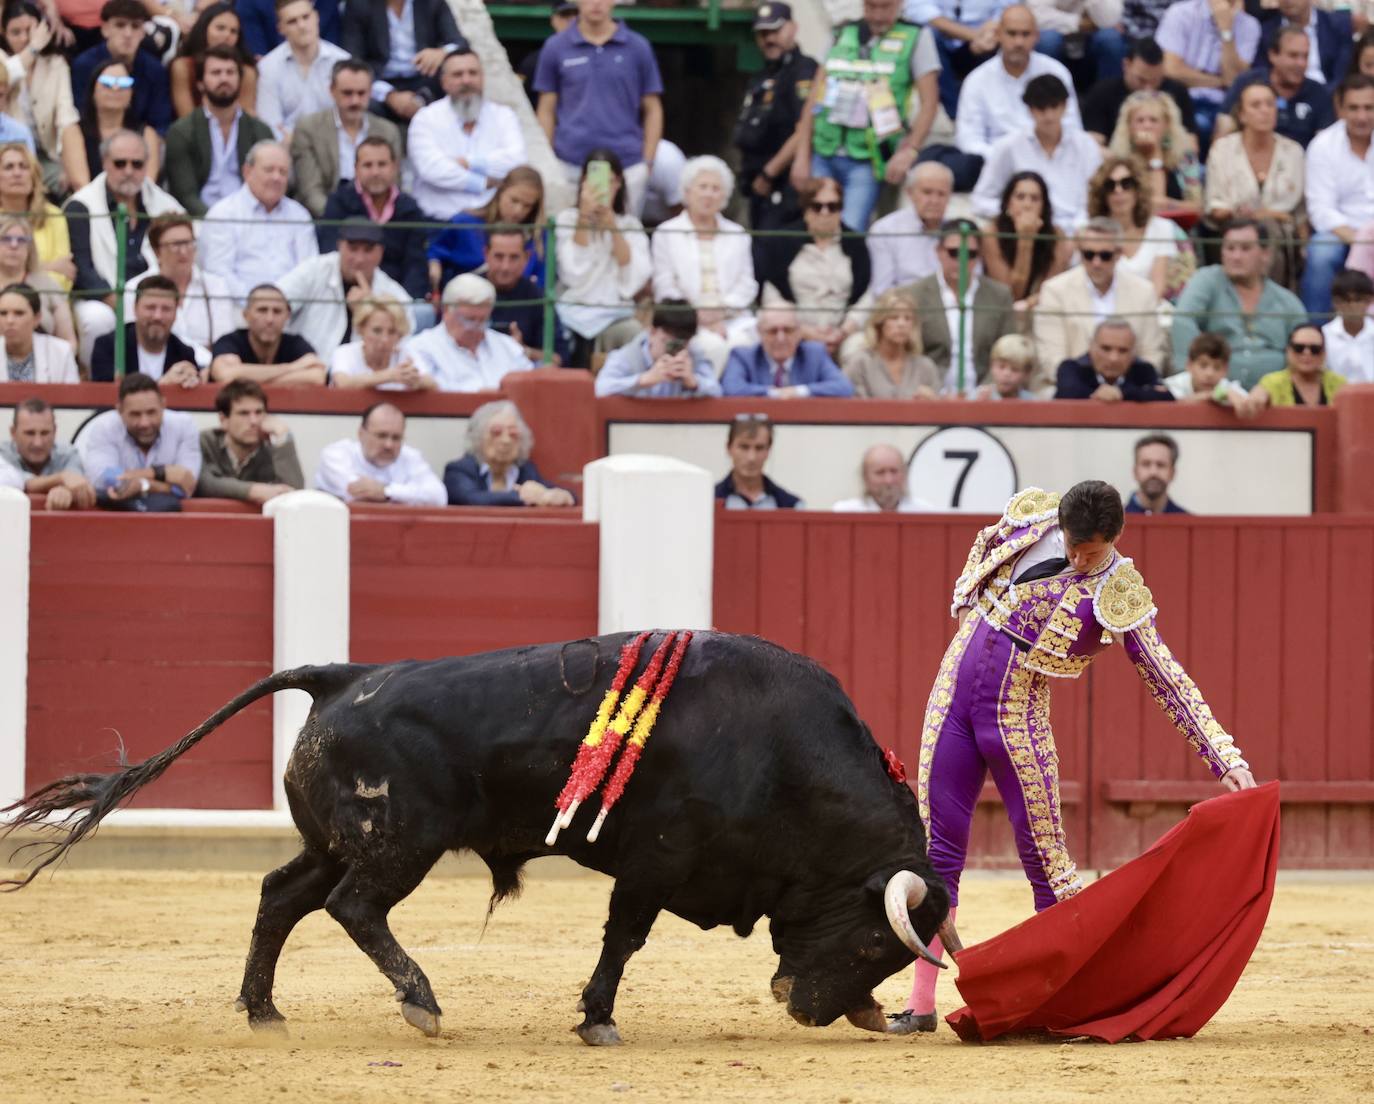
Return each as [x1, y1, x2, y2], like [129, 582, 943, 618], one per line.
[901, 219, 1017, 396]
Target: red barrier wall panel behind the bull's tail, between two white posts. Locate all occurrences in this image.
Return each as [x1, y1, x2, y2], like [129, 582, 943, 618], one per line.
[26, 513, 272, 808]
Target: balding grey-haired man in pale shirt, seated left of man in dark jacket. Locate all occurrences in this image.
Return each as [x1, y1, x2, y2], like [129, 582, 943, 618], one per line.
[201, 144, 320, 302]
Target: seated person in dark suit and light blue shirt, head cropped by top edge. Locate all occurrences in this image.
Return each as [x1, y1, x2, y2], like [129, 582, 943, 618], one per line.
[344, 0, 467, 126]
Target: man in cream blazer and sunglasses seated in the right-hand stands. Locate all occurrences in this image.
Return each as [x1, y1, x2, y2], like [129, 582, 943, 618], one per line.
[1031, 219, 1169, 395]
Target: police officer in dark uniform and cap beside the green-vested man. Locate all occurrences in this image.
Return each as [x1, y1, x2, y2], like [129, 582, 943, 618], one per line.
[735, 3, 816, 230]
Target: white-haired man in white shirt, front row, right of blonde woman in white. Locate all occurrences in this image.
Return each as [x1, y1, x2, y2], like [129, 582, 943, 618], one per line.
[405, 272, 533, 392]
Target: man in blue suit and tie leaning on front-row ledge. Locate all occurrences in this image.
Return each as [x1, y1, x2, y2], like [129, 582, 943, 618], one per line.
[720, 304, 855, 399]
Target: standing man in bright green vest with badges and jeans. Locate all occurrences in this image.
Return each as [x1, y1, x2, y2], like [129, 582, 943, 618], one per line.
[791, 0, 940, 230]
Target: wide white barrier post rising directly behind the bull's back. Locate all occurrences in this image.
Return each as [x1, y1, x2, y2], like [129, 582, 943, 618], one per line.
[583, 454, 716, 632]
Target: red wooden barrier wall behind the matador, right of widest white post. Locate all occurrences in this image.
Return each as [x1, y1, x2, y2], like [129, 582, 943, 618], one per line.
[714, 511, 1374, 868]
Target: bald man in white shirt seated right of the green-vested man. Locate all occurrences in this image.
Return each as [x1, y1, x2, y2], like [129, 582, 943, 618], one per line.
[938, 4, 1083, 191]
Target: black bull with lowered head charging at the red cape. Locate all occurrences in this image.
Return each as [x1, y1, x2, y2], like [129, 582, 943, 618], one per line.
[5, 632, 948, 1044]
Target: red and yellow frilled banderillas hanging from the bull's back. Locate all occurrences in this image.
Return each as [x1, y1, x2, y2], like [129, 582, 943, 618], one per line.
[544, 632, 692, 847]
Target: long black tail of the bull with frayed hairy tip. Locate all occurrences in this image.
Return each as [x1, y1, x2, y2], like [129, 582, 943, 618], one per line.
[0, 664, 361, 891]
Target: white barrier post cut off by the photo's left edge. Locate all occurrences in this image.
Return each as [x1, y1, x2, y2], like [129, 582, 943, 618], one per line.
[0, 487, 29, 806]
